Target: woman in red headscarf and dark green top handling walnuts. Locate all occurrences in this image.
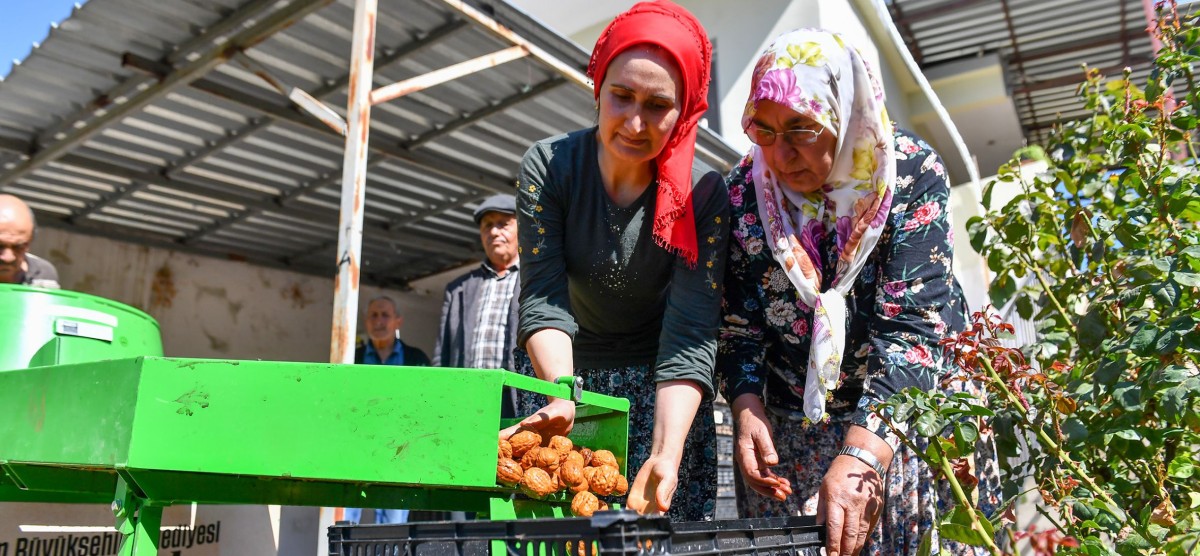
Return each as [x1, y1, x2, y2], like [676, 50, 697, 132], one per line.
[501, 1, 730, 520]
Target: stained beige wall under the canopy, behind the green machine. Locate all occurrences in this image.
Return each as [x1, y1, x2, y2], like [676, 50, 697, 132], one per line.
[31, 228, 452, 361]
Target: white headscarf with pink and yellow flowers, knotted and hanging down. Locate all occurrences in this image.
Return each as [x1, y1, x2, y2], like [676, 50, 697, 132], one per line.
[742, 29, 896, 420]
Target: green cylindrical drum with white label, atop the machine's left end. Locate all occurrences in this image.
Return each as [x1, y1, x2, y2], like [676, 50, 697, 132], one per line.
[0, 283, 162, 371]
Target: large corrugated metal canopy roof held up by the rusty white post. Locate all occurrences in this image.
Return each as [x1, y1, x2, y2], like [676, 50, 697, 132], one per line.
[0, 0, 738, 286]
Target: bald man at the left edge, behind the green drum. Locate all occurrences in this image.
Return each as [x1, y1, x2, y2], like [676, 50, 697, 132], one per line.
[0, 195, 59, 288]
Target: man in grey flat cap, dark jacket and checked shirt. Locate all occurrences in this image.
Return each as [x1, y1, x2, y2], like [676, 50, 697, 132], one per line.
[433, 195, 521, 417]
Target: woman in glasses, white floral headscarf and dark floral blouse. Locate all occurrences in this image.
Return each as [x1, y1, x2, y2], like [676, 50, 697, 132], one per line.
[716, 30, 996, 555]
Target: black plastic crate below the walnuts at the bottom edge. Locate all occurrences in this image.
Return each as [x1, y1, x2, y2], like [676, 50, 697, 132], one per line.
[329, 510, 824, 556]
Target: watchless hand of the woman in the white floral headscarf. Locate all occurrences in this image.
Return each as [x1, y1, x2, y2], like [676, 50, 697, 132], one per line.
[732, 394, 792, 501]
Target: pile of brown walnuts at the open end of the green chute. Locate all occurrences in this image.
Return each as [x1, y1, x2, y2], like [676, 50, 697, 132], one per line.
[496, 430, 629, 518]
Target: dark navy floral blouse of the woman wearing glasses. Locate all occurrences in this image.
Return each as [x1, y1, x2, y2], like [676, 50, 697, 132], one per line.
[716, 130, 965, 448]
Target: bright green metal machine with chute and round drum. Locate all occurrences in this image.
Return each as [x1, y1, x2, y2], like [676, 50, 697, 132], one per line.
[0, 286, 629, 556]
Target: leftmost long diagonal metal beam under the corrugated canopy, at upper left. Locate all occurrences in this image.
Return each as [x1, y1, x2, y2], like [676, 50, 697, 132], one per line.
[0, 0, 331, 186]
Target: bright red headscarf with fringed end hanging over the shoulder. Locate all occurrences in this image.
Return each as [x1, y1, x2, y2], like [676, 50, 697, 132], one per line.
[588, 0, 713, 267]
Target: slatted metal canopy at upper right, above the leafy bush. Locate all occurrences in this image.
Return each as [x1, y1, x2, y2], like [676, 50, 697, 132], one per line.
[888, 0, 1196, 142]
